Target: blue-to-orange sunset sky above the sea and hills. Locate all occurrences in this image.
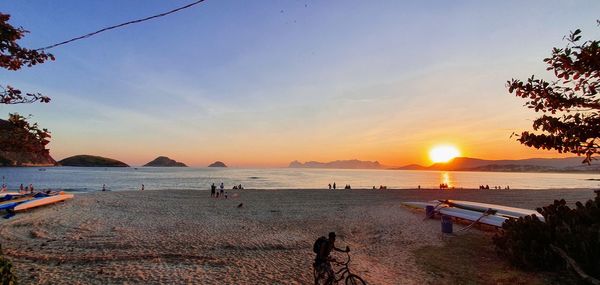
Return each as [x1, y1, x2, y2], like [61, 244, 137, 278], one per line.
[0, 0, 600, 167]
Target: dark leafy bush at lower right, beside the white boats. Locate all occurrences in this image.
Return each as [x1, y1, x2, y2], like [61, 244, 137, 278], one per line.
[493, 190, 600, 278]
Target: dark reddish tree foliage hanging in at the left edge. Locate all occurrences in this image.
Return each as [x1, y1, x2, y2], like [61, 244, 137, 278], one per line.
[0, 12, 54, 156]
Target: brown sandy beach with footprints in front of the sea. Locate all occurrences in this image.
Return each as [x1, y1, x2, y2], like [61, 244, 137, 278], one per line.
[0, 189, 593, 284]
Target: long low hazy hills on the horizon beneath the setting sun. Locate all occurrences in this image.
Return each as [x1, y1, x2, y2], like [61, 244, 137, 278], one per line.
[393, 157, 600, 173]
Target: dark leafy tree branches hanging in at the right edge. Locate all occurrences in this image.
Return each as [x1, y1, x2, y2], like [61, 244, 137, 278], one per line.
[507, 21, 600, 164]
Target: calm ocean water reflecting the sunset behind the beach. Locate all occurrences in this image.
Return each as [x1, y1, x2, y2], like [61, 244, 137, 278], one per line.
[0, 167, 600, 192]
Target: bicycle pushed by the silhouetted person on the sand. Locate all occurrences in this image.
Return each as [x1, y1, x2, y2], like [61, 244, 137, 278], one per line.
[313, 248, 367, 285]
